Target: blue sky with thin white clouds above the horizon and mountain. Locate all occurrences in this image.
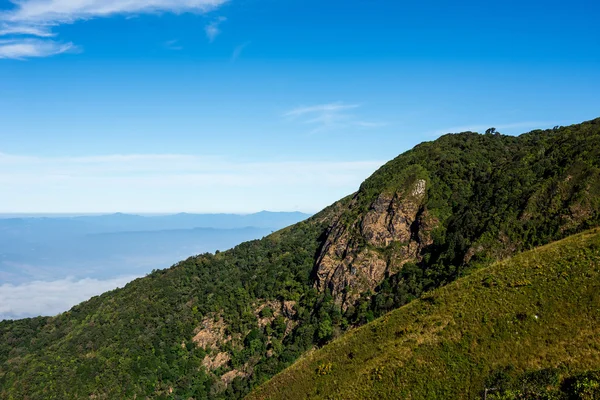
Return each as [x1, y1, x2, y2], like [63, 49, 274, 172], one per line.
[0, 0, 600, 213]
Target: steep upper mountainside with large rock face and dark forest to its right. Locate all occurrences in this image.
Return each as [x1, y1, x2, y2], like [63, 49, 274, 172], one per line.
[316, 119, 600, 312]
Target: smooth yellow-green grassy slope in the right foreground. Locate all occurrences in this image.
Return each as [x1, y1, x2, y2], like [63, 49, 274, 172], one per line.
[249, 229, 600, 399]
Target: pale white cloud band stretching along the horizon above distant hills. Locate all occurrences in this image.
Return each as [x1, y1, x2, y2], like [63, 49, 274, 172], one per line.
[0, 153, 383, 213]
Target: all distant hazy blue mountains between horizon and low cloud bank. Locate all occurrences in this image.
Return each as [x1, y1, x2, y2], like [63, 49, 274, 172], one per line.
[0, 211, 309, 285]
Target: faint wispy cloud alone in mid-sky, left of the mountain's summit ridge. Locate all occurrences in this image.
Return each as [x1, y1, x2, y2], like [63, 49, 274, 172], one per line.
[283, 102, 386, 133]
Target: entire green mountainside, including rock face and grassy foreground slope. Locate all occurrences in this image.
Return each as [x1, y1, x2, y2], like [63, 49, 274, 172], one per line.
[0, 119, 600, 400]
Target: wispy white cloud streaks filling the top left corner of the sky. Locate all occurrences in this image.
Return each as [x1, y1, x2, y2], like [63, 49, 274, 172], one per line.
[0, 0, 228, 59]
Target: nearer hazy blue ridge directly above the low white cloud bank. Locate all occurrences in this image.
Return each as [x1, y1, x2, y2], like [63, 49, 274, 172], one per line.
[0, 228, 272, 285]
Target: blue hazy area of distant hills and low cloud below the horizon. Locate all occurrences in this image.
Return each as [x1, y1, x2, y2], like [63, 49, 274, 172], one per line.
[0, 211, 309, 320]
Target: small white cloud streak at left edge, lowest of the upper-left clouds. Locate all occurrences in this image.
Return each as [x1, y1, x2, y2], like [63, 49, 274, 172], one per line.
[0, 39, 76, 60]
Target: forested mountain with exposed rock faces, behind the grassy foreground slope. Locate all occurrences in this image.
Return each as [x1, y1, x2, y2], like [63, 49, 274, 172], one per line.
[0, 119, 600, 399]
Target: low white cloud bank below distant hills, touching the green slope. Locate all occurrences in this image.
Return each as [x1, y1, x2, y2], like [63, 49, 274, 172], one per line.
[0, 276, 136, 320]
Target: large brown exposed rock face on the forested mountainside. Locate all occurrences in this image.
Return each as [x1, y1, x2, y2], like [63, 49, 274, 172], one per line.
[315, 180, 436, 310]
